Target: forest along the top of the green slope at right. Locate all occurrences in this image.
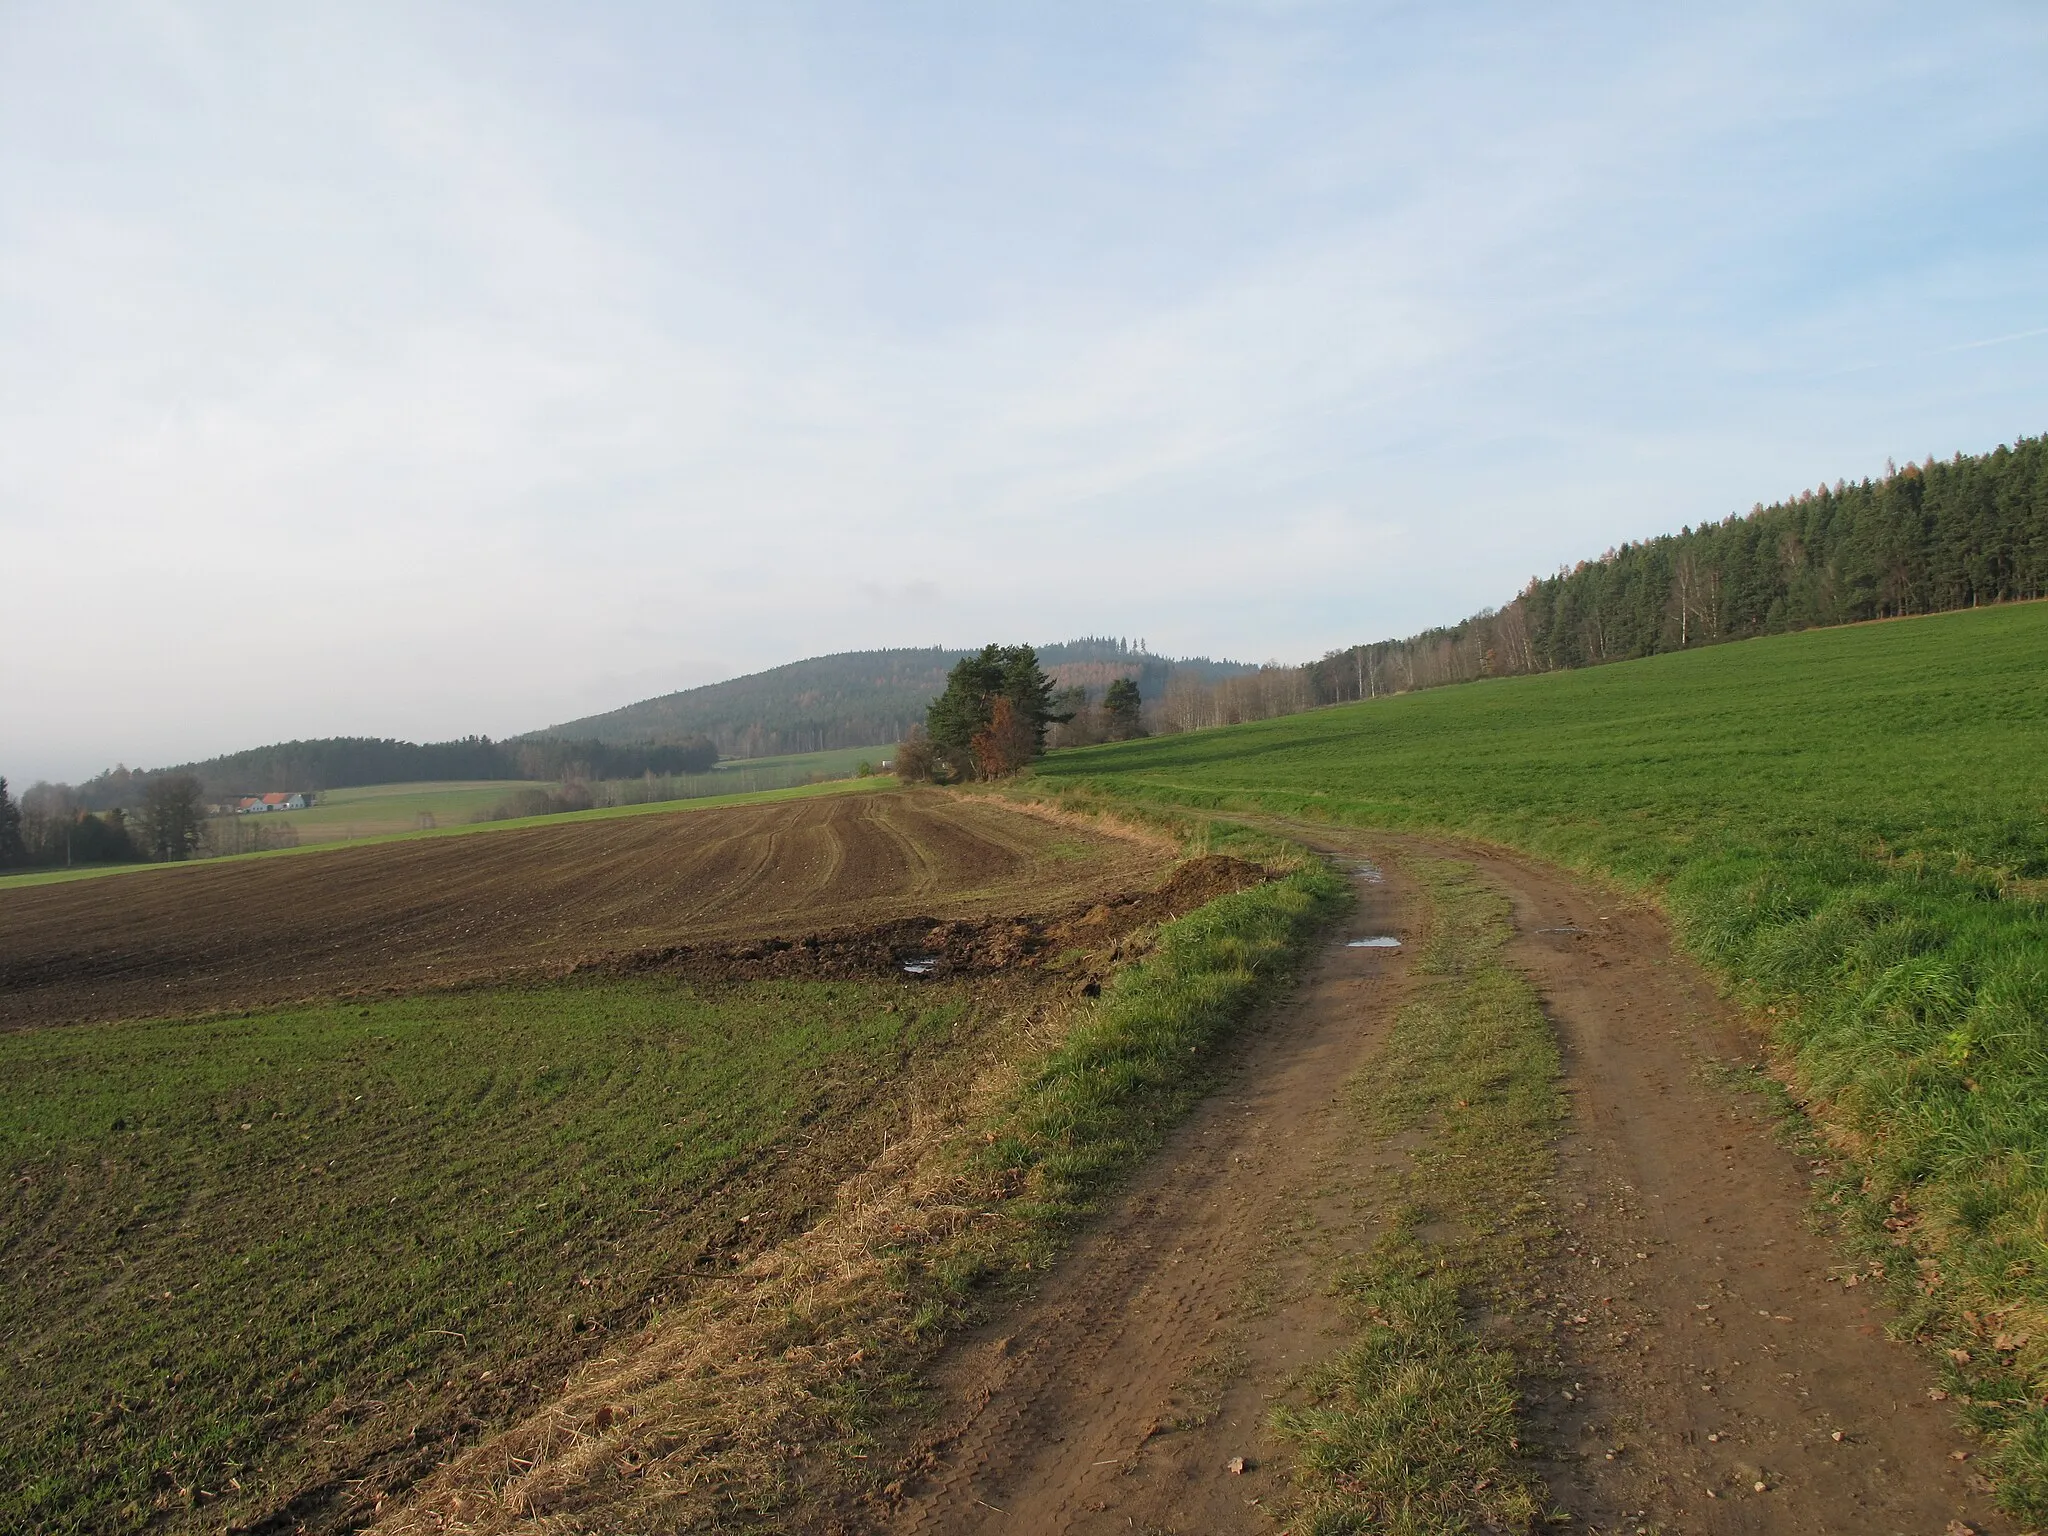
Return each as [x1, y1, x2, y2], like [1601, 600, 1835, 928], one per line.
[1153, 428, 2048, 731]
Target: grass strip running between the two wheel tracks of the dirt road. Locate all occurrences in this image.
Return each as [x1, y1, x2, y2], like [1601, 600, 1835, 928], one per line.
[1274, 860, 1565, 1536]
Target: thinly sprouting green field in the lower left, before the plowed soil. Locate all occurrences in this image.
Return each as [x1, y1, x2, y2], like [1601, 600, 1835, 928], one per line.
[0, 981, 991, 1532]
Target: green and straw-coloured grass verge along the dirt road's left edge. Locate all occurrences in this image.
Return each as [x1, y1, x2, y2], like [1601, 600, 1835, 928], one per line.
[383, 835, 1348, 1532]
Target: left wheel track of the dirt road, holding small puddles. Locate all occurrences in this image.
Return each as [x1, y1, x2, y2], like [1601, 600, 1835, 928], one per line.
[887, 860, 1417, 1534]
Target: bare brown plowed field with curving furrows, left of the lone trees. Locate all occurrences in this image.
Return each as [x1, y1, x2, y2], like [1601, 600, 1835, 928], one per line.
[0, 791, 1165, 1028]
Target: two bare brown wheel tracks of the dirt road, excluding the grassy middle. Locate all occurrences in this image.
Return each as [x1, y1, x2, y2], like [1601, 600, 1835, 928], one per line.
[889, 843, 2011, 1536]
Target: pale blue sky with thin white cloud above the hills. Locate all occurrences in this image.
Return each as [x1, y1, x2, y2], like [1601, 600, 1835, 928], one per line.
[0, 0, 2048, 774]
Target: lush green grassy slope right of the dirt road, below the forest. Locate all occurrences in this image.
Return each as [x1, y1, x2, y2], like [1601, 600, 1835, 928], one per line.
[1040, 604, 2048, 1516]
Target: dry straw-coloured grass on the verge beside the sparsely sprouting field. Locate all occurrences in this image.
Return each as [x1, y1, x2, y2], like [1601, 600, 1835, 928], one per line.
[377, 1004, 1071, 1536]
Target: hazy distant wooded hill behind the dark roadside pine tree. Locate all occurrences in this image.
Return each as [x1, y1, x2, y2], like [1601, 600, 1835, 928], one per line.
[535, 637, 1255, 758]
